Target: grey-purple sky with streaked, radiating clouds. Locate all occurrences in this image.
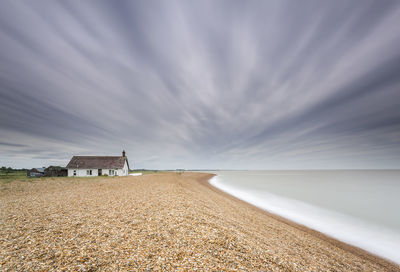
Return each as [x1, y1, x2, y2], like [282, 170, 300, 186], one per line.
[0, 0, 400, 169]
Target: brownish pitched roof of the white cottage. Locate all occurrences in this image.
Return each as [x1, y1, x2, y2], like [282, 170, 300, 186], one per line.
[67, 156, 129, 169]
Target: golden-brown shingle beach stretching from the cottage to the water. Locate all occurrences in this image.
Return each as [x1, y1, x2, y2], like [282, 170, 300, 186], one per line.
[0, 173, 400, 271]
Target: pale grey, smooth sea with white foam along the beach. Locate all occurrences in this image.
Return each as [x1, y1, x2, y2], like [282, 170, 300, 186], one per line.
[210, 170, 400, 264]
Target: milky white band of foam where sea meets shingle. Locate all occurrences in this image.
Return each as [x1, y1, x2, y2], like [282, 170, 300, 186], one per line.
[209, 176, 400, 264]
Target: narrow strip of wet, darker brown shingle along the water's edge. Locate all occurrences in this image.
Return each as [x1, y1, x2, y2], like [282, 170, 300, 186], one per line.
[198, 174, 400, 271]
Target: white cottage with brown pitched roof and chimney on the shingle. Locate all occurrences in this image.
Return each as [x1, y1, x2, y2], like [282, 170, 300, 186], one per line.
[67, 151, 129, 177]
